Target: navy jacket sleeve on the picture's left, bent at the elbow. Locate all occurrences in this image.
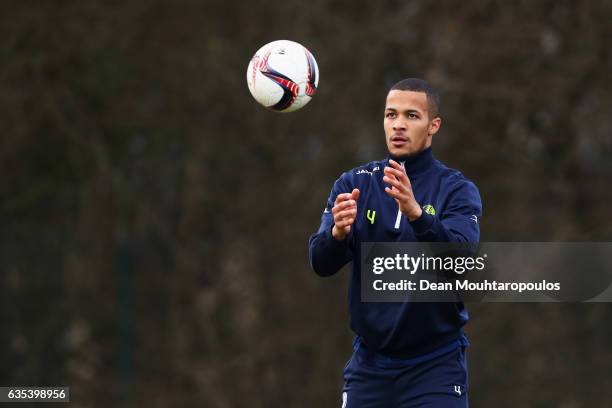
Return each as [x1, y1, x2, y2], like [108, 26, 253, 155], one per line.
[308, 173, 354, 276]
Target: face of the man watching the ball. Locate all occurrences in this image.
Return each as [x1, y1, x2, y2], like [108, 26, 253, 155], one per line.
[383, 90, 442, 156]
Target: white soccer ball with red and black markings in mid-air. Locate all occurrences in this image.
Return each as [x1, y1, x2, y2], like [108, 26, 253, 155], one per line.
[247, 40, 319, 112]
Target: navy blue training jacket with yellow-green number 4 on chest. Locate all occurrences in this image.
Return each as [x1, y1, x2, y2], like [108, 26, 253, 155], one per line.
[309, 148, 482, 358]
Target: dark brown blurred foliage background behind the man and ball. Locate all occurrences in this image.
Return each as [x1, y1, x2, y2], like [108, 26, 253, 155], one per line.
[0, 0, 612, 408]
